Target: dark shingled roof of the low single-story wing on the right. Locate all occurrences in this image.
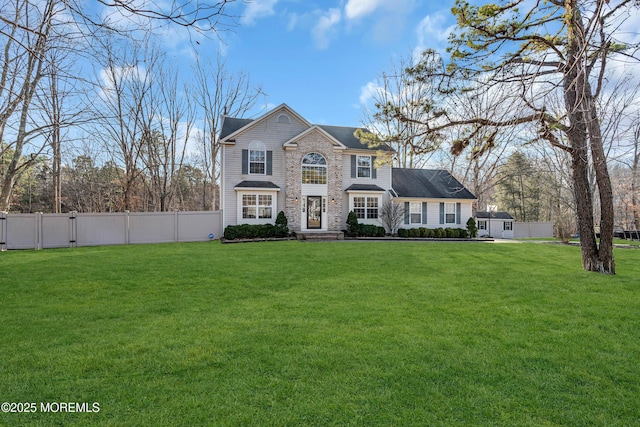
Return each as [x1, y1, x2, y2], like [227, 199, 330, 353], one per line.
[391, 168, 476, 199]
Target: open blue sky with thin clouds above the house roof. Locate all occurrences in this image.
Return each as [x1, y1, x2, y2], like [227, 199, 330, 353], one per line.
[205, 0, 454, 126]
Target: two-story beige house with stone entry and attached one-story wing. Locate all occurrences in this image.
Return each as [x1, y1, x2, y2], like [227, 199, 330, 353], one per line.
[220, 104, 475, 236]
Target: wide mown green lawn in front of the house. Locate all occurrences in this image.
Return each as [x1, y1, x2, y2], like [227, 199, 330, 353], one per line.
[0, 241, 640, 426]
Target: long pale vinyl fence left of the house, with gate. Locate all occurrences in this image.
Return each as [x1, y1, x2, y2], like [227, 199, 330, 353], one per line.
[0, 211, 222, 250]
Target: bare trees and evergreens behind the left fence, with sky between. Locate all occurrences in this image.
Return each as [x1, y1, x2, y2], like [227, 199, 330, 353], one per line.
[0, 0, 263, 212]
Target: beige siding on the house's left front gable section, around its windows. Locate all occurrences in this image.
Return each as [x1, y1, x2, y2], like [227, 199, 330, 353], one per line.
[223, 112, 307, 227]
